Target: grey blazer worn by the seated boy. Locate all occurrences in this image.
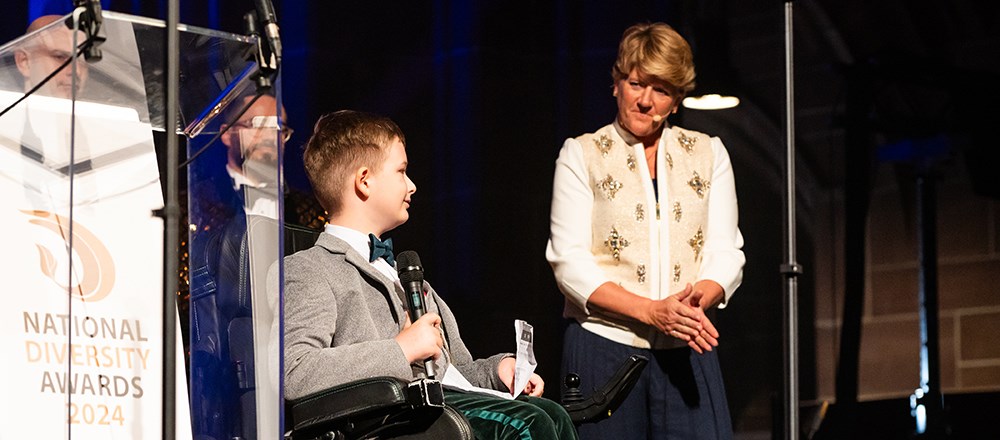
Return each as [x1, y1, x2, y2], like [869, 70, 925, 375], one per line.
[284, 233, 510, 399]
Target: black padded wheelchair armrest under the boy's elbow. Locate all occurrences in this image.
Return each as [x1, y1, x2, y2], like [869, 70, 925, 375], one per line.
[285, 377, 444, 439]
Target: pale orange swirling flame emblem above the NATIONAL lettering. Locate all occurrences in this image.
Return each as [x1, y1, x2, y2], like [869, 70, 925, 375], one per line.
[21, 210, 115, 301]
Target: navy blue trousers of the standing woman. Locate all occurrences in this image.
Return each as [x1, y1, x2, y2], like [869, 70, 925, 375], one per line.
[562, 321, 733, 440]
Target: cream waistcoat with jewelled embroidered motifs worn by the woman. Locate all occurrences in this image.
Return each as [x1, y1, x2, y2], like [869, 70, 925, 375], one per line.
[577, 124, 714, 348]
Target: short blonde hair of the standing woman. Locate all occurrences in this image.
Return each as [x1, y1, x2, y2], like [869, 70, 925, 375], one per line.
[611, 23, 695, 95]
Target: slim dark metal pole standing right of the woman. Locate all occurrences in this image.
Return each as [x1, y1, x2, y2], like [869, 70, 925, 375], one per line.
[781, 0, 802, 440]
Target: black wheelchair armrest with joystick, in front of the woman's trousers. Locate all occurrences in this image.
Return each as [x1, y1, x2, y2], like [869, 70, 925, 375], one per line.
[563, 355, 649, 425]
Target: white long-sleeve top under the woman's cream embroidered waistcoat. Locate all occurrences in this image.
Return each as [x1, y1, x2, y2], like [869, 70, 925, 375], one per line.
[546, 124, 745, 345]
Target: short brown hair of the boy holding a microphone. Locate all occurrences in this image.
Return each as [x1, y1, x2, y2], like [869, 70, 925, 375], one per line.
[303, 110, 406, 215]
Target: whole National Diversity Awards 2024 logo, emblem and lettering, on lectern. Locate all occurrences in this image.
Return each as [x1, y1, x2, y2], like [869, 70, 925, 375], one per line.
[18, 209, 151, 430]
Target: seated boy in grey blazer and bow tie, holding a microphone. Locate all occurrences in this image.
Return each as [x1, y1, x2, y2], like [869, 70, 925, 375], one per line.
[284, 110, 576, 439]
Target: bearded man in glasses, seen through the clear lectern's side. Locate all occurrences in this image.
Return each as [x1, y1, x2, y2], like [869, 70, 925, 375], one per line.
[189, 94, 322, 438]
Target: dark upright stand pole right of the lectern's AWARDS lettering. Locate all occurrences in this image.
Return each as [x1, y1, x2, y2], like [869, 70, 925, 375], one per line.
[162, 0, 180, 440]
